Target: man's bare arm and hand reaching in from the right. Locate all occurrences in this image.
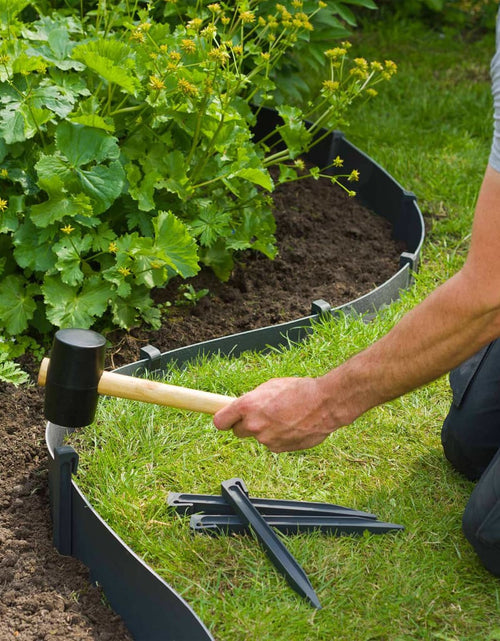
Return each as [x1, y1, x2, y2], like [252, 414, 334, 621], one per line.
[214, 167, 500, 452]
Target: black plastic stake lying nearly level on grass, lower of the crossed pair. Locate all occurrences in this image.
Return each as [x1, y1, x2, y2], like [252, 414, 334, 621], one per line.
[189, 514, 404, 536]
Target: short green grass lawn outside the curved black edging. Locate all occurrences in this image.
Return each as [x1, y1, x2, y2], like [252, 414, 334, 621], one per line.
[68, 15, 500, 641]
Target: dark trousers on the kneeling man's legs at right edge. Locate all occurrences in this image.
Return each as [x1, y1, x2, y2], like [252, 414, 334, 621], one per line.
[441, 339, 500, 576]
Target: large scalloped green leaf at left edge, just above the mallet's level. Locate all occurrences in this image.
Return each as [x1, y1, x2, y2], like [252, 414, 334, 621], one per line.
[0, 275, 39, 336]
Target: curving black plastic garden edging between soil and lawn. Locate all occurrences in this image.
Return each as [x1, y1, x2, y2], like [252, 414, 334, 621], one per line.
[45, 121, 424, 641]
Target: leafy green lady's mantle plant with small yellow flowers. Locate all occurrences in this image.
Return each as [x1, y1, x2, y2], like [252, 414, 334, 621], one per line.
[0, 0, 395, 350]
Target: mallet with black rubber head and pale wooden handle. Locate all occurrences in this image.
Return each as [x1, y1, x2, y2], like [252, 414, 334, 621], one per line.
[38, 329, 234, 427]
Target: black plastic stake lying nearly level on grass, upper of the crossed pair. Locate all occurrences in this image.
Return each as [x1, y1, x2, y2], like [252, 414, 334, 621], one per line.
[167, 492, 377, 519]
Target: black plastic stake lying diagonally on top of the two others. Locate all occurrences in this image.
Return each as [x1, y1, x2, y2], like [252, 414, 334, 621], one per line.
[221, 479, 321, 609]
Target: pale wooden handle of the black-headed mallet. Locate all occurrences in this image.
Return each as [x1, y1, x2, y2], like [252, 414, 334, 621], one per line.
[38, 358, 234, 414]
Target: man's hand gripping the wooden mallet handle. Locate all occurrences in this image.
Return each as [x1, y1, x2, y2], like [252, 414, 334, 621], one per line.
[214, 378, 340, 452]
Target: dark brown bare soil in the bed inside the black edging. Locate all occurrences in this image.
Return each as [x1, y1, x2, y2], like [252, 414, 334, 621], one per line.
[0, 172, 403, 641]
